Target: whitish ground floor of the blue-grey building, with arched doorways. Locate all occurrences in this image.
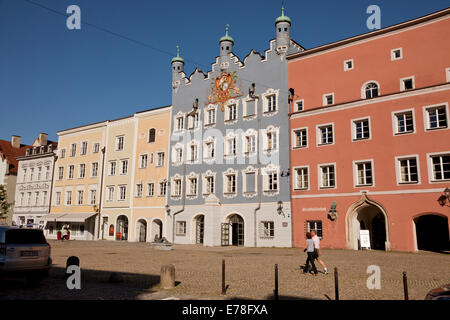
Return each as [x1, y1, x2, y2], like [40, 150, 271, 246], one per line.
[166, 198, 292, 247]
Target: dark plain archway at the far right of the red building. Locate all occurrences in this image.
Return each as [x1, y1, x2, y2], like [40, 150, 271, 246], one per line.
[414, 214, 450, 251]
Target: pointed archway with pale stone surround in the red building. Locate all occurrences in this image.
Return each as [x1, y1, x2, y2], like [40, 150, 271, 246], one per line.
[346, 193, 390, 250]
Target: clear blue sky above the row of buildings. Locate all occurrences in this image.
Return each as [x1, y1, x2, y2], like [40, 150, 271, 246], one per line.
[0, 0, 449, 144]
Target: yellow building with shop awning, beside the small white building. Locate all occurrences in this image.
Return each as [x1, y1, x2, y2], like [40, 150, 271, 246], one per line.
[44, 121, 108, 240]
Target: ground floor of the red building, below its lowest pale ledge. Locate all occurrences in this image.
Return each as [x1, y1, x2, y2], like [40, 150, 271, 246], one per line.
[292, 192, 450, 252]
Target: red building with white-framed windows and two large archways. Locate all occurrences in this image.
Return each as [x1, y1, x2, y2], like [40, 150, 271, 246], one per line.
[288, 9, 450, 251]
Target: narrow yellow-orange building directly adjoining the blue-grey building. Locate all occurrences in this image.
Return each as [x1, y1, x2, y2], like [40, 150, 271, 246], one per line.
[133, 107, 172, 242]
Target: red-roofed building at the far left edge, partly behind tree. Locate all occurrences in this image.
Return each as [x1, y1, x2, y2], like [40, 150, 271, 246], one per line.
[0, 135, 29, 225]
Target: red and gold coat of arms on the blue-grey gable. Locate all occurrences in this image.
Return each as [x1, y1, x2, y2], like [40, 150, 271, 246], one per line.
[206, 71, 242, 111]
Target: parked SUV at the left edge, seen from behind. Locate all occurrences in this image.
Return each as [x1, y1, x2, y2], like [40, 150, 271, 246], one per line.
[0, 226, 52, 283]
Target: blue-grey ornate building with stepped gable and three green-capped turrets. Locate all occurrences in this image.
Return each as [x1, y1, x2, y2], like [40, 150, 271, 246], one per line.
[166, 10, 304, 247]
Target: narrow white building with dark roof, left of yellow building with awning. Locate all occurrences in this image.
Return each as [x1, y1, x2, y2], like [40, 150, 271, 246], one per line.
[12, 133, 57, 229]
